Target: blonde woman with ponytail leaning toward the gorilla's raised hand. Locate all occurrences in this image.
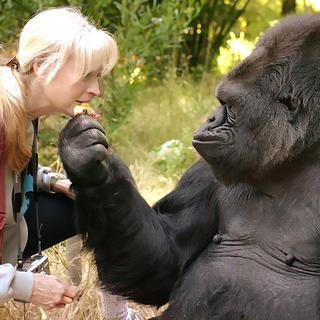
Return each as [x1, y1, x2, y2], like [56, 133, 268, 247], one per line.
[0, 8, 136, 318]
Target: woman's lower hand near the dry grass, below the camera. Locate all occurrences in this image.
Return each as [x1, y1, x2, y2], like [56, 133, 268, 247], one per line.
[30, 273, 80, 309]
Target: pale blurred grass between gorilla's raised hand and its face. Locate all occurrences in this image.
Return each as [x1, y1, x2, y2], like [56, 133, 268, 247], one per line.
[104, 77, 214, 178]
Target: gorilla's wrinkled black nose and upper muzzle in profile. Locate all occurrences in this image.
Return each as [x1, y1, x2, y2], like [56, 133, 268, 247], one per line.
[193, 106, 227, 140]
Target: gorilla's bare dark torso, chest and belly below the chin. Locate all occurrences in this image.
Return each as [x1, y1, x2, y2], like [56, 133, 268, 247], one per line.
[161, 190, 320, 320]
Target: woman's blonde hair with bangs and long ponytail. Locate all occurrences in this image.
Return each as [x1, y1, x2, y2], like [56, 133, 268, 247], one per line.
[0, 7, 118, 172]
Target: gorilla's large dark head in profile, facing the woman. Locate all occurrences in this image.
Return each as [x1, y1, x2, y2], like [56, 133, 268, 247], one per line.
[193, 15, 320, 183]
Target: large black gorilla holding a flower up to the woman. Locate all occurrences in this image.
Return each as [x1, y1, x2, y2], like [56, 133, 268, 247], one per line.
[59, 14, 320, 320]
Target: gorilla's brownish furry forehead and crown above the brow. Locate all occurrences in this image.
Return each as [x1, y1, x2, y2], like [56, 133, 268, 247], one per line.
[221, 14, 320, 97]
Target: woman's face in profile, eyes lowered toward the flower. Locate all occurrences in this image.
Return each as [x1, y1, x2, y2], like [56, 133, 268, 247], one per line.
[28, 59, 100, 117]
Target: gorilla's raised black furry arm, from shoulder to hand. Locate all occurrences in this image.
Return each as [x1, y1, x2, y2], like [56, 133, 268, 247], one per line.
[60, 118, 217, 306]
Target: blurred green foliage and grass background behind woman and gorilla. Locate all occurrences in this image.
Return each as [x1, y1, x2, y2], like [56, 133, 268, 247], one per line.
[0, 0, 320, 176]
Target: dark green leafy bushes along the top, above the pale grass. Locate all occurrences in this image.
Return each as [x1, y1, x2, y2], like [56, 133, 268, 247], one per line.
[0, 0, 320, 74]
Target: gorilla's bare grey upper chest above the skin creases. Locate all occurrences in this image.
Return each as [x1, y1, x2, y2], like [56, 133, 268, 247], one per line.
[215, 184, 320, 266]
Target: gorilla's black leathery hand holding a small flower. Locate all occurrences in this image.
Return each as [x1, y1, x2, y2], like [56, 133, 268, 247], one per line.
[59, 116, 108, 187]
